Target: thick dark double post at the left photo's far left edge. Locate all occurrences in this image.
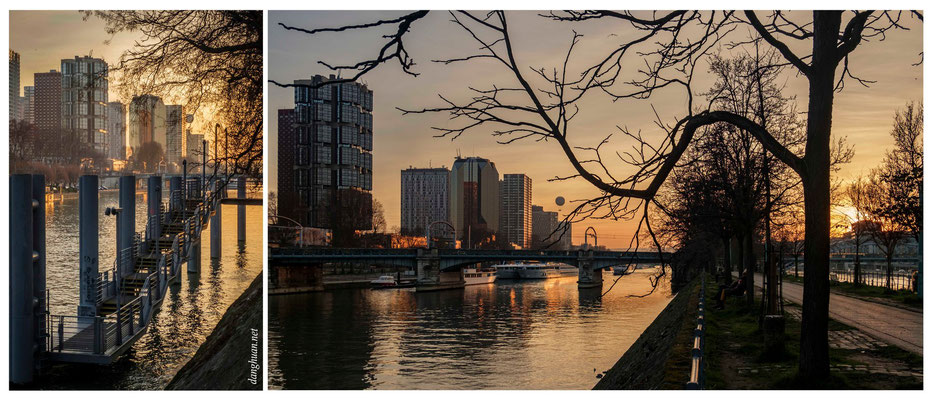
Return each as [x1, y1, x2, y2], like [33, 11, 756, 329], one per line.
[9, 174, 46, 384]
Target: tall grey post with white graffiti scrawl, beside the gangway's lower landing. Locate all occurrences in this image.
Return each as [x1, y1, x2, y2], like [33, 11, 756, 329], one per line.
[78, 175, 100, 317]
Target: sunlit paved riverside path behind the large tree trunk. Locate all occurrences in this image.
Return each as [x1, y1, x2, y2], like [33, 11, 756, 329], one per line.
[755, 274, 923, 356]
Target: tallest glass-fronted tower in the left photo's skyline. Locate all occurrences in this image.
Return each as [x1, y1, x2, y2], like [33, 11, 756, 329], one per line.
[61, 56, 110, 154]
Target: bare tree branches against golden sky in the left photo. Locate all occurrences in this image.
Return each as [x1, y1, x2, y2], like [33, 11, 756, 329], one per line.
[85, 10, 263, 177]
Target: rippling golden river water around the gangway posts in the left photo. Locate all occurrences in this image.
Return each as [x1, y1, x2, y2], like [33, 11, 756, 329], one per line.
[31, 191, 263, 389]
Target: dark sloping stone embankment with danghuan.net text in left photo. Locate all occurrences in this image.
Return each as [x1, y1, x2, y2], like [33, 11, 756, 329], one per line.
[165, 273, 263, 390]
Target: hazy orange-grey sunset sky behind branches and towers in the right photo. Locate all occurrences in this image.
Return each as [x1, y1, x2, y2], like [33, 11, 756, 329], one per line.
[268, 11, 923, 248]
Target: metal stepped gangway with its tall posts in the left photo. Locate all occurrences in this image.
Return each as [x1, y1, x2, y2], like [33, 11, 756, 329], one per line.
[10, 175, 258, 383]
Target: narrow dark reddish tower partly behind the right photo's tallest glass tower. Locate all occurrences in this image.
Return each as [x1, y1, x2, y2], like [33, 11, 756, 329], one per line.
[276, 108, 296, 221]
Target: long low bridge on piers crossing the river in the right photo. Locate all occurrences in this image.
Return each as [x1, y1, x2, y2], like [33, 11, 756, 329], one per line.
[269, 247, 670, 291]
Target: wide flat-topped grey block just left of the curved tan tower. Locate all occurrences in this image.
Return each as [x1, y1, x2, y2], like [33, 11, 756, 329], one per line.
[401, 167, 450, 235]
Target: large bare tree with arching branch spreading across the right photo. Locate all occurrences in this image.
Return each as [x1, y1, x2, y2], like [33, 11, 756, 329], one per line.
[273, 11, 922, 382]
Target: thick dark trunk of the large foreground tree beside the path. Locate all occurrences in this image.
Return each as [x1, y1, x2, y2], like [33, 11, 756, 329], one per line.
[798, 11, 841, 383]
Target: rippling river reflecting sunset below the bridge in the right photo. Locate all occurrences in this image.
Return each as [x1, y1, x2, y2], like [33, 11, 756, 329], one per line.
[268, 268, 671, 389]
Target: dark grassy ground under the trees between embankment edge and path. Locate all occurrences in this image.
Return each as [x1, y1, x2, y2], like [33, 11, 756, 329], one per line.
[700, 277, 923, 390]
